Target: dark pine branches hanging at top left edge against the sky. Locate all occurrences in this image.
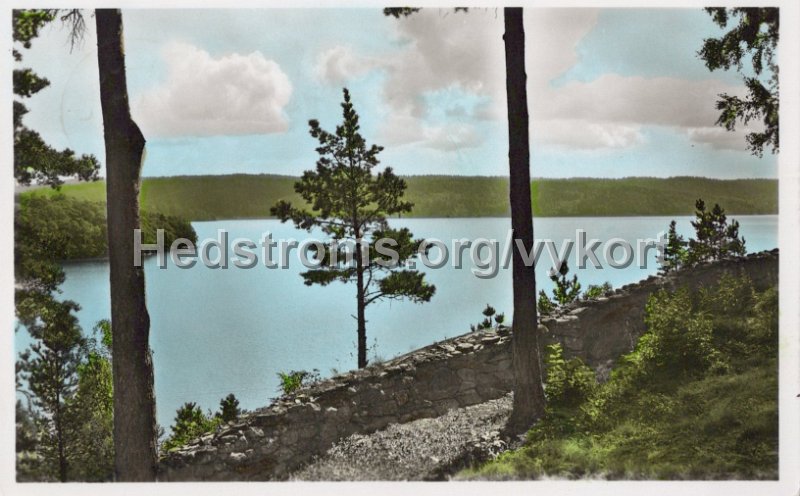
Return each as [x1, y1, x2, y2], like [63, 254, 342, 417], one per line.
[12, 10, 100, 187]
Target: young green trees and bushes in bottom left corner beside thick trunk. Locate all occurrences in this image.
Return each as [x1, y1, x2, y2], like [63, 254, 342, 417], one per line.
[17, 316, 114, 481]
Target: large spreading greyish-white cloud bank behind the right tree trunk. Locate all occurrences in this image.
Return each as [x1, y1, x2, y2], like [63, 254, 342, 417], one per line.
[318, 9, 743, 150]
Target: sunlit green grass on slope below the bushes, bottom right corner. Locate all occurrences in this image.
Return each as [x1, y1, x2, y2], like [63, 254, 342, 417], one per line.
[466, 360, 778, 480]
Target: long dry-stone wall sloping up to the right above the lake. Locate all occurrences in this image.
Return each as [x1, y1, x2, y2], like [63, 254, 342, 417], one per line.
[159, 250, 778, 481]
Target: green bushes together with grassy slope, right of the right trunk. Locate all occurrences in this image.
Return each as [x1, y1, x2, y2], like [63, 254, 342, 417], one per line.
[462, 274, 778, 479]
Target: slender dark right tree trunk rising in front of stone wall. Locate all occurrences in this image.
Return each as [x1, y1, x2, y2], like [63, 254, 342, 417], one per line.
[503, 7, 544, 435]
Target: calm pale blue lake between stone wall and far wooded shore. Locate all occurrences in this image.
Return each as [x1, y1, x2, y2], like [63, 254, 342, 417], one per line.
[15, 215, 778, 427]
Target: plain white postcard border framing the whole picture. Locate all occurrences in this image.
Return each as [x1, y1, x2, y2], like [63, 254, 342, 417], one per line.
[0, 0, 800, 496]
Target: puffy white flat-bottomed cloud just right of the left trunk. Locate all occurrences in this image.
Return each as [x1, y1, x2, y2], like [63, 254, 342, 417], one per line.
[133, 43, 292, 136]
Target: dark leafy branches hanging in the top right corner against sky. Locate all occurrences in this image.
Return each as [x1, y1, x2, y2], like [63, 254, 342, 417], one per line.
[698, 7, 780, 156]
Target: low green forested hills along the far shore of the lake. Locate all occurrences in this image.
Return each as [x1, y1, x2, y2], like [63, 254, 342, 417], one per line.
[23, 174, 778, 221]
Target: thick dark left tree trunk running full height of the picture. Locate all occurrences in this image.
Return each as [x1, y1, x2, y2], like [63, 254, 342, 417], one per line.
[95, 9, 156, 482]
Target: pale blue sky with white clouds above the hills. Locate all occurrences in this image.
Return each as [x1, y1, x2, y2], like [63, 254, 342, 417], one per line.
[18, 8, 778, 178]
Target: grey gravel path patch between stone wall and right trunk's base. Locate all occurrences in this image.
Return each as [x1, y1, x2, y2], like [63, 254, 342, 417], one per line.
[290, 395, 511, 481]
